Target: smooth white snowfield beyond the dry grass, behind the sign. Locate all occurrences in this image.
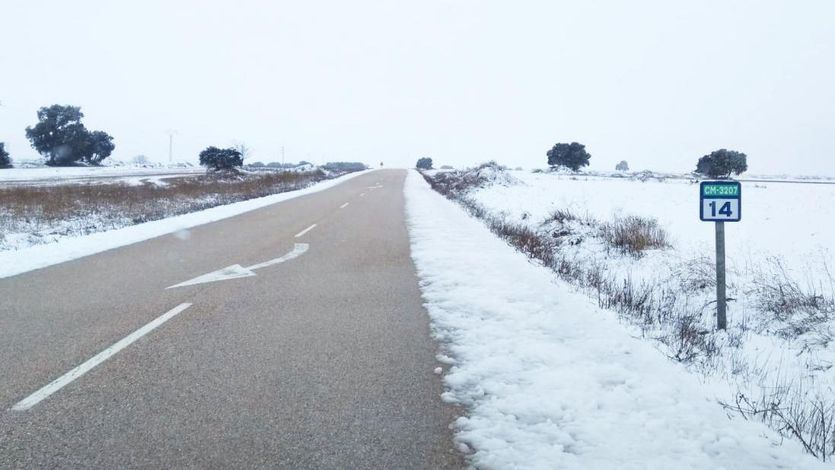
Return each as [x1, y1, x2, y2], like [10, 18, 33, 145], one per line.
[472, 171, 835, 275]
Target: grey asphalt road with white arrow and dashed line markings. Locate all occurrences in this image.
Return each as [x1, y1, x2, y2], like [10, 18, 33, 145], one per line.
[0, 170, 463, 469]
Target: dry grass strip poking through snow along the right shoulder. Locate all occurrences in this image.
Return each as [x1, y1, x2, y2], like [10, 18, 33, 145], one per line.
[424, 163, 835, 460]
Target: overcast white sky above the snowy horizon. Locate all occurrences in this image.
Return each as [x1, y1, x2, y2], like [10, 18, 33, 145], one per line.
[0, 0, 835, 175]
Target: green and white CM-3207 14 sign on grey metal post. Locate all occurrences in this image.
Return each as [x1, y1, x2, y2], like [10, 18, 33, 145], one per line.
[699, 181, 742, 330]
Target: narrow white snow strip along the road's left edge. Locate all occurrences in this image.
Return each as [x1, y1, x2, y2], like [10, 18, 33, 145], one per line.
[0, 171, 368, 278]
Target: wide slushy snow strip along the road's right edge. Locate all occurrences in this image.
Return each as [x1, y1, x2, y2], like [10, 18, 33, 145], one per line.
[405, 172, 822, 469]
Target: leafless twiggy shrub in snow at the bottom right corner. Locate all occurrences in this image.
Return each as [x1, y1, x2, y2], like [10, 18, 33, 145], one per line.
[720, 382, 835, 462]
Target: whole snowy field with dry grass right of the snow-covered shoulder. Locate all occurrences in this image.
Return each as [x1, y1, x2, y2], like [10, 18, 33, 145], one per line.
[428, 163, 835, 461]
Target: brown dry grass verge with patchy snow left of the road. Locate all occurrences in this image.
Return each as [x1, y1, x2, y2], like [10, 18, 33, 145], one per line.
[0, 170, 328, 251]
